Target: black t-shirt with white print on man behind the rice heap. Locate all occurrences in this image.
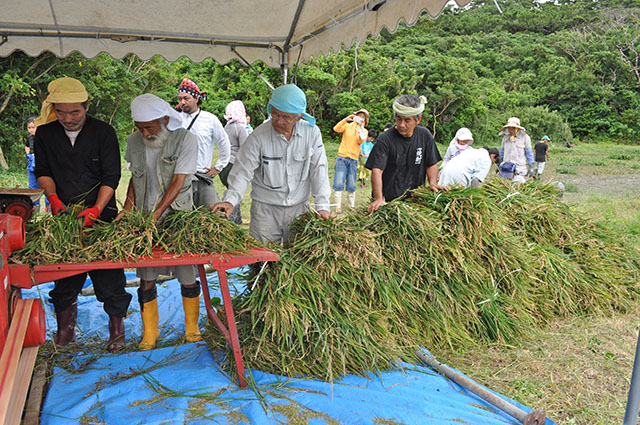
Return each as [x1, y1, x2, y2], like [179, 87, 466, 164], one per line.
[365, 126, 442, 202]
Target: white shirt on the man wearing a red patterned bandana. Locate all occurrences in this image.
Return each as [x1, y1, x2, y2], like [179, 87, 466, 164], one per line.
[180, 109, 231, 173]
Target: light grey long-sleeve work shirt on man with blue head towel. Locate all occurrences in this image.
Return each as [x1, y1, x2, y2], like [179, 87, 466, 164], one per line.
[223, 120, 331, 211]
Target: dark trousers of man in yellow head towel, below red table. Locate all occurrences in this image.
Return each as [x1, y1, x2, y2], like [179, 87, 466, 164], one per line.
[49, 269, 131, 317]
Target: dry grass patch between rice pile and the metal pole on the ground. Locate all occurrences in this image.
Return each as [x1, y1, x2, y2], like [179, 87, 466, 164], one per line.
[434, 310, 640, 425]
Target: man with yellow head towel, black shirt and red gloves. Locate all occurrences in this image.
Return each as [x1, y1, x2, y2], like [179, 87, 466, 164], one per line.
[34, 77, 131, 352]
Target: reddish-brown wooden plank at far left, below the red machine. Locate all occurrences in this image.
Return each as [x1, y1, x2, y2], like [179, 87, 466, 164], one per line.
[0, 299, 34, 424]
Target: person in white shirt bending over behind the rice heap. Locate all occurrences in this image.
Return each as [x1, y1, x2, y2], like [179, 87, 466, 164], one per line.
[438, 146, 500, 187]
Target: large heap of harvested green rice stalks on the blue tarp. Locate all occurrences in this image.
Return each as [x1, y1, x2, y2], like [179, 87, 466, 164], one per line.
[206, 179, 639, 380]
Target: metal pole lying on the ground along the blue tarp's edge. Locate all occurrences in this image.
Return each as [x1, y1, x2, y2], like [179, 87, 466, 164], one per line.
[416, 350, 546, 425]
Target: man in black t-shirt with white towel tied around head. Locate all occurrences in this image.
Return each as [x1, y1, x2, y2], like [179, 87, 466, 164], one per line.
[365, 95, 448, 212]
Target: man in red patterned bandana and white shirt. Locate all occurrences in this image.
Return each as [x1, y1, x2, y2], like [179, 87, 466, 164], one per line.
[178, 78, 231, 207]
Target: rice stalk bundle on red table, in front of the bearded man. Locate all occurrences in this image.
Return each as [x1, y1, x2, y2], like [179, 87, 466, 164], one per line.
[156, 208, 261, 255]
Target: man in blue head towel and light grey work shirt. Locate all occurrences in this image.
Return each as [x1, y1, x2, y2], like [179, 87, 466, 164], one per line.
[209, 84, 331, 244]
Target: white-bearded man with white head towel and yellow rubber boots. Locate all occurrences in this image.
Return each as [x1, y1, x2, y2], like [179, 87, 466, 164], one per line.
[119, 94, 202, 350]
